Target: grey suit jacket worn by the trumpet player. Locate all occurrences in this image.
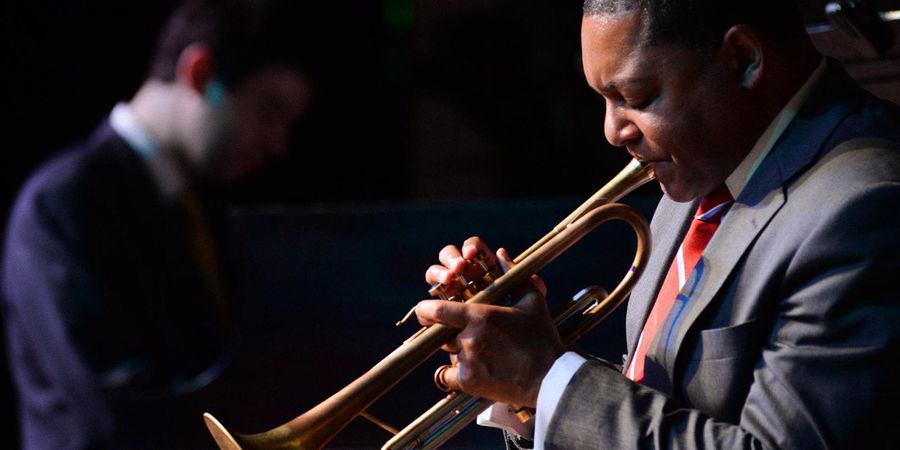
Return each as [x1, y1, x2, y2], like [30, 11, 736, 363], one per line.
[545, 64, 900, 449]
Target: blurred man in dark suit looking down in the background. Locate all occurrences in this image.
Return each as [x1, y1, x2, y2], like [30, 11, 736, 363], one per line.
[0, 0, 310, 449]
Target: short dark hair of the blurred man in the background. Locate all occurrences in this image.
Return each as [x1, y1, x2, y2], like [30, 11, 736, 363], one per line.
[148, 0, 308, 87]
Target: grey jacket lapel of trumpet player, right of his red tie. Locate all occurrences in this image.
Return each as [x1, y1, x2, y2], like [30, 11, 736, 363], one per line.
[648, 60, 854, 382]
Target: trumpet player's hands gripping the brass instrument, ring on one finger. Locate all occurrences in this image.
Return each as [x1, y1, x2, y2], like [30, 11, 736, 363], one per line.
[416, 237, 565, 407]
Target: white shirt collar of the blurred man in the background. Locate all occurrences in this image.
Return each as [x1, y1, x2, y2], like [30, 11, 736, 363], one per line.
[109, 102, 187, 200]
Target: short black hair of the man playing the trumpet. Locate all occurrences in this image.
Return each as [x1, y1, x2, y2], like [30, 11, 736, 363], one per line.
[584, 0, 806, 50]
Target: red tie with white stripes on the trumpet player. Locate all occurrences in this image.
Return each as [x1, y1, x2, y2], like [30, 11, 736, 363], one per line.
[625, 184, 734, 382]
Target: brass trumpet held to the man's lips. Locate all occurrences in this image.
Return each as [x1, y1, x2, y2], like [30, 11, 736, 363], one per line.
[203, 160, 654, 450]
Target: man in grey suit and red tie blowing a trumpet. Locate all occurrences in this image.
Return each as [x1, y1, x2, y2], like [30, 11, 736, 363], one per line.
[416, 0, 900, 448]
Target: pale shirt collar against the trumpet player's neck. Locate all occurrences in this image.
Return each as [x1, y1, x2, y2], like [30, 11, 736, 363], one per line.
[725, 58, 827, 198]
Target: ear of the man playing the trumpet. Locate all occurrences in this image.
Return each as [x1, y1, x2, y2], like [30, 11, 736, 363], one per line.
[720, 25, 766, 89]
